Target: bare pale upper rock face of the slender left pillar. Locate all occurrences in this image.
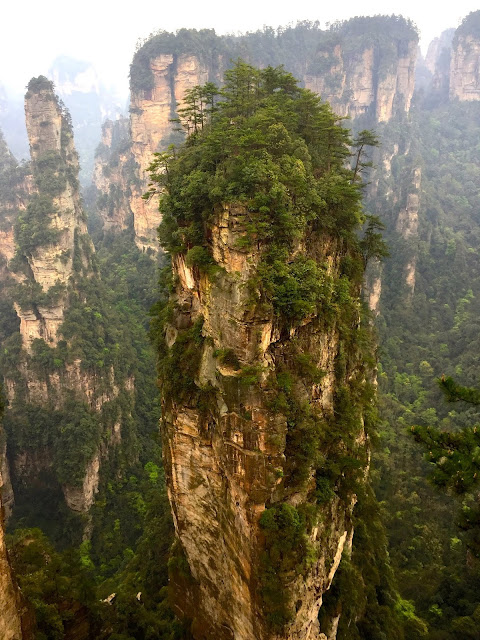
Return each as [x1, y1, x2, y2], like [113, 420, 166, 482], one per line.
[16, 79, 87, 348]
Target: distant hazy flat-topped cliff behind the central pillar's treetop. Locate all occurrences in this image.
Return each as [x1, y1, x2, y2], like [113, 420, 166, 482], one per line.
[94, 16, 418, 252]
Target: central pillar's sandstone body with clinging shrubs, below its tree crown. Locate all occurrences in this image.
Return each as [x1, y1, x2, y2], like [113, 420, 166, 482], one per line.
[160, 72, 371, 640]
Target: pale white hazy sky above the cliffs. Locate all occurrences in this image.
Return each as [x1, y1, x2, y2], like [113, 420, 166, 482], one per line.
[0, 0, 479, 92]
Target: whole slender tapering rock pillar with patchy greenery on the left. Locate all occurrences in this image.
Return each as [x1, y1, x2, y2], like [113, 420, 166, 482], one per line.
[0, 76, 133, 512]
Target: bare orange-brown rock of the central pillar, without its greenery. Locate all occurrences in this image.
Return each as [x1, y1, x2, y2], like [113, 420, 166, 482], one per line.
[163, 205, 367, 640]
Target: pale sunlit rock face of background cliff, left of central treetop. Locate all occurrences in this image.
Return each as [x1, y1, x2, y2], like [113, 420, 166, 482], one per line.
[130, 54, 208, 251]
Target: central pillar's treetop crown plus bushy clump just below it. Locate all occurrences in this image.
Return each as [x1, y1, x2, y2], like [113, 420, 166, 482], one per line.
[147, 60, 385, 325]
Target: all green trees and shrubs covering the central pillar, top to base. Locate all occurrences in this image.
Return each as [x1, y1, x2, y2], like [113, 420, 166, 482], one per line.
[147, 61, 395, 632]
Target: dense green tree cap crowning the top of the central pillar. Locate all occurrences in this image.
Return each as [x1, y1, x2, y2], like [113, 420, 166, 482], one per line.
[151, 61, 378, 276]
